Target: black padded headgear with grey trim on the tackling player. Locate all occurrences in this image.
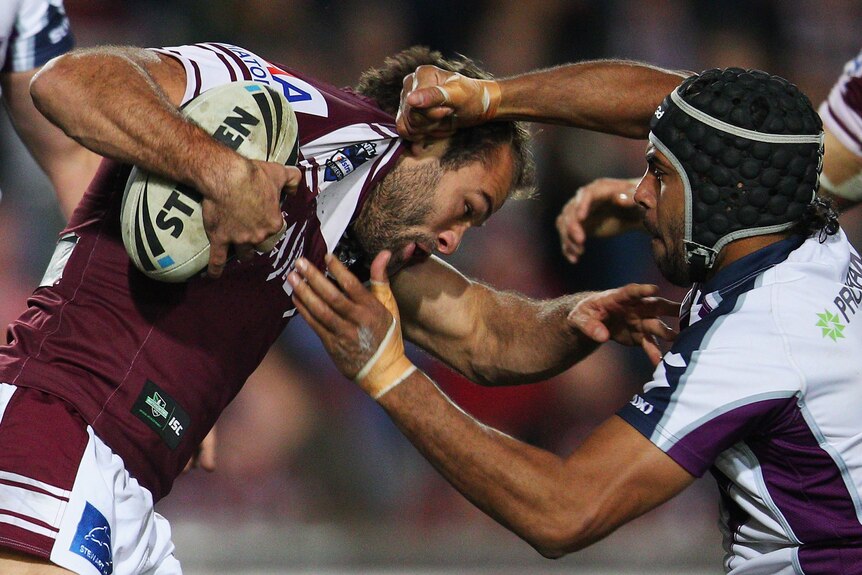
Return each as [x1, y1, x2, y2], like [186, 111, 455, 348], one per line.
[649, 68, 823, 281]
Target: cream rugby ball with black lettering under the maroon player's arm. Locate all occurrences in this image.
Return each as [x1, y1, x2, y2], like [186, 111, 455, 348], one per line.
[120, 82, 298, 282]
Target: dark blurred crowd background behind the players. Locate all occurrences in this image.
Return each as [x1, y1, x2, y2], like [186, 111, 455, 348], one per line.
[0, 0, 862, 575]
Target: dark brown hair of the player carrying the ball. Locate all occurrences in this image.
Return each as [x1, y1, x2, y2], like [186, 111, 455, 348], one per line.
[355, 46, 535, 198]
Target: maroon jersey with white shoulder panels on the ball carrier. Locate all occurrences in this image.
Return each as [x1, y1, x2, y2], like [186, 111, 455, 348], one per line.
[0, 44, 403, 500]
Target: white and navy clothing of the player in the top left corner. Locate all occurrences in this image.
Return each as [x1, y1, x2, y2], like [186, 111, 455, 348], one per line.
[0, 0, 73, 72]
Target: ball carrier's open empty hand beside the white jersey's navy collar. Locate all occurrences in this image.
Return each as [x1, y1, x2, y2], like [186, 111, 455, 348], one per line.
[568, 284, 679, 365]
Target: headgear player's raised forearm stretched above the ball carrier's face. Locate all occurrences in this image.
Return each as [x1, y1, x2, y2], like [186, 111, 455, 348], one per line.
[496, 61, 685, 138]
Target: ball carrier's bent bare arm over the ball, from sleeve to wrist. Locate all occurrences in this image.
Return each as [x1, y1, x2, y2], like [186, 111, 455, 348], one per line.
[30, 48, 249, 195]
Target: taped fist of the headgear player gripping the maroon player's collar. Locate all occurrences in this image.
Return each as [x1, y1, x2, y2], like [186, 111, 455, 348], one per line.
[395, 65, 501, 141]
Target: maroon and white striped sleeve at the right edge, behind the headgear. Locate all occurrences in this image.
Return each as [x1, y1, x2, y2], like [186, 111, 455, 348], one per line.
[818, 47, 862, 156]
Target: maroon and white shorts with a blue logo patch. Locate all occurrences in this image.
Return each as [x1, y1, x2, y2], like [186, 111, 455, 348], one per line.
[0, 383, 182, 575]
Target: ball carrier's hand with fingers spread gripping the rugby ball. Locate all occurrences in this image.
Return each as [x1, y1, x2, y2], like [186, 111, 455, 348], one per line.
[203, 160, 302, 278]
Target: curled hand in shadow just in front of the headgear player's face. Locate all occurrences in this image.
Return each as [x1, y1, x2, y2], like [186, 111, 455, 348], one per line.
[557, 178, 641, 264]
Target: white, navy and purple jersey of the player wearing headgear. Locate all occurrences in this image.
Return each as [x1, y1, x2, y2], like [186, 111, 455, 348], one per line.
[619, 231, 862, 575]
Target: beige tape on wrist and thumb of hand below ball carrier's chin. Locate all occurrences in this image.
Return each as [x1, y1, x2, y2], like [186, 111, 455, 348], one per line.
[354, 281, 416, 399]
